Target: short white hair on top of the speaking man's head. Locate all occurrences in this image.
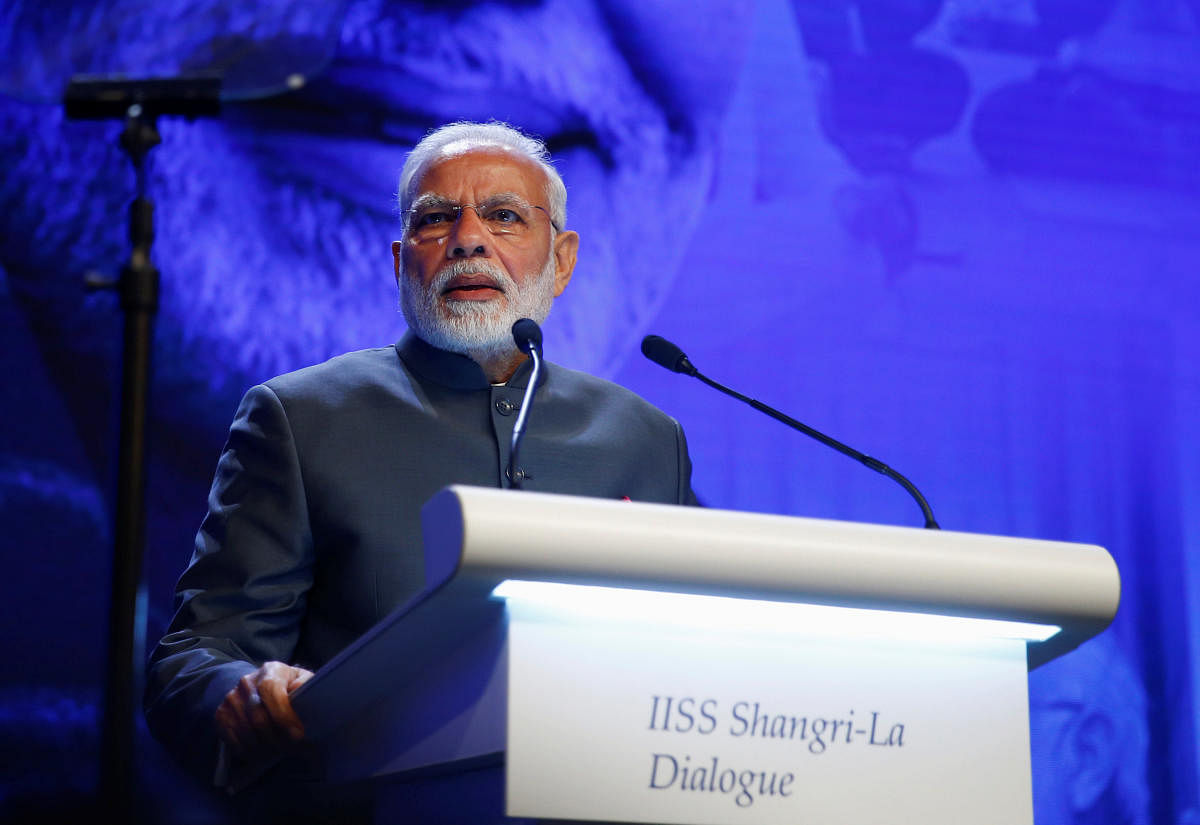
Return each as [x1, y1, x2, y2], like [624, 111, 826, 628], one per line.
[396, 120, 566, 233]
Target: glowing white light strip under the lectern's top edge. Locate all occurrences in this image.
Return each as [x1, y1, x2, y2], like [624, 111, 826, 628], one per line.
[492, 579, 1062, 642]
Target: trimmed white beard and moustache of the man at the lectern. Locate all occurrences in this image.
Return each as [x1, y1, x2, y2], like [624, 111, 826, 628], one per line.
[400, 248, 554, 363]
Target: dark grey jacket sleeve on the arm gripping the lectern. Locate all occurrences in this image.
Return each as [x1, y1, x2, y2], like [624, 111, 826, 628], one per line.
[145, 386, 313, 779]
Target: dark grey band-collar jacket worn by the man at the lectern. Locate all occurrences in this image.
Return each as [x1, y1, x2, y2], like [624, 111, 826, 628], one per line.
[146, 333, 695, 773]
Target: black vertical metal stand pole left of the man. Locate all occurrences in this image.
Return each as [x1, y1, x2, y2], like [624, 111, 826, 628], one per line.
[100, 106, 160, 823]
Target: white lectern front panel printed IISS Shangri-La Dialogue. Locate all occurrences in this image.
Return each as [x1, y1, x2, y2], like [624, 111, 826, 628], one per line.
[506, 601, 1032, 825]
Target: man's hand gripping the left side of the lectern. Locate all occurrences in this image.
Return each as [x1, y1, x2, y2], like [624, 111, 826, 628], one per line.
[214, 662, 312, 757]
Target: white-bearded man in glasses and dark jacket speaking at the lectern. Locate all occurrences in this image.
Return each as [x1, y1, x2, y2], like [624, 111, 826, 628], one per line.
[146, 122, 695, 776]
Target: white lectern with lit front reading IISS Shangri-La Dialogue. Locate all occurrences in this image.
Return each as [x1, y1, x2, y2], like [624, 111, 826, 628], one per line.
[285, 487, 1120, 825]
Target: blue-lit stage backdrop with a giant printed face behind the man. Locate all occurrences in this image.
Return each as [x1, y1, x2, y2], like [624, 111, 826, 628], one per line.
[0, 0, 1200, 825]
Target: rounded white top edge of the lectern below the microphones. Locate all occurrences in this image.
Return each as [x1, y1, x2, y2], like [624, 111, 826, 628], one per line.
[422, 486, 1120, 666]
